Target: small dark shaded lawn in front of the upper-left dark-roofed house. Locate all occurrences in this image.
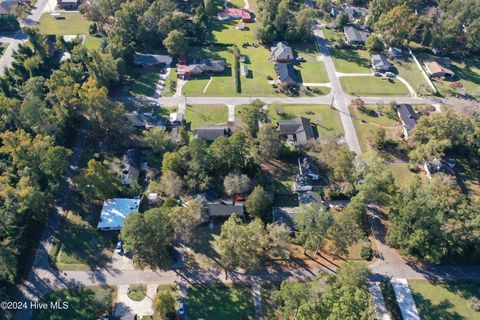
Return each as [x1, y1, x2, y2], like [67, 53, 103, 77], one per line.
[127, 67, 160, 97]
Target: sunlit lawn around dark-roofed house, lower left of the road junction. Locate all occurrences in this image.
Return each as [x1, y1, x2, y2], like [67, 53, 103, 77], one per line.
[268, 104, 343, 135]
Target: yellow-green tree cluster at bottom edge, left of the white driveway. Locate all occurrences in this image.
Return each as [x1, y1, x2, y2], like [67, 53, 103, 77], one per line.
[273, 263, 375, 320]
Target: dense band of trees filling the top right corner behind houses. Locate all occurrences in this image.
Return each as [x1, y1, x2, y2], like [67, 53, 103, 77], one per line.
[368, 0, 480, 54]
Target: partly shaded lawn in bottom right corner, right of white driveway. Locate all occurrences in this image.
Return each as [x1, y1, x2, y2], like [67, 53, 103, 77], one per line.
[408, 280, 480, 320]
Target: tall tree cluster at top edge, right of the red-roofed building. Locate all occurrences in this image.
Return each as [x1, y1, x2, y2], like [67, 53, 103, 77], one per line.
[257, 0, 315, 43]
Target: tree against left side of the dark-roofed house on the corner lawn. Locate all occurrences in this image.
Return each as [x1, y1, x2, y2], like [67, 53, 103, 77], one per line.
[254, 124, 282, 163]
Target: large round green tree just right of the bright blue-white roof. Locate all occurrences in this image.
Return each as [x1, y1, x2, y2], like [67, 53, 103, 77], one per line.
[120, 208, 174, 270]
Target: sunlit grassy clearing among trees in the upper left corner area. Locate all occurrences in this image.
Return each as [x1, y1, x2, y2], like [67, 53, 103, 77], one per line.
[38, 12, 101, 48]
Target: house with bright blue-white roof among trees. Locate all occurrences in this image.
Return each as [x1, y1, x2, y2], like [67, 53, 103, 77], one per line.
[97, 198, 140, 230]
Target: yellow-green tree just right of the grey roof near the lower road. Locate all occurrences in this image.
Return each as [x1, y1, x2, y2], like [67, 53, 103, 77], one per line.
[294, 204, 333, 253]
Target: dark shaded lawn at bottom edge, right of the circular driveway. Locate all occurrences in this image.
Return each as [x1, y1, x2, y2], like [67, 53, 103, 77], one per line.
[185, 285, 254, 320]
